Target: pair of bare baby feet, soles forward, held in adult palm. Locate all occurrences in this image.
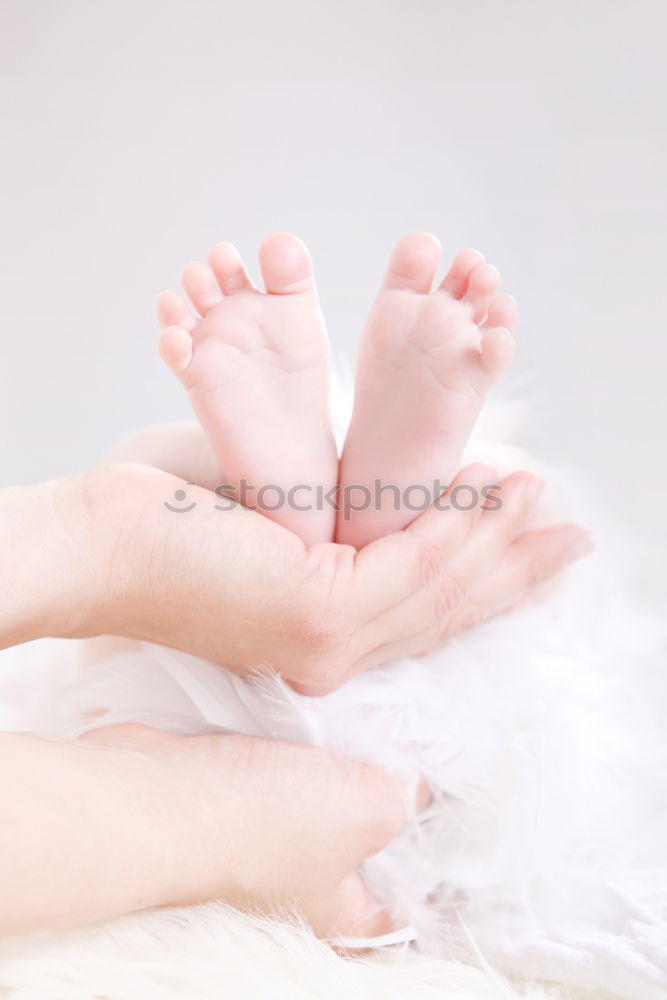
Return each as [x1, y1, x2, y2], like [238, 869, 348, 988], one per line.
[158, 233, 517, 548]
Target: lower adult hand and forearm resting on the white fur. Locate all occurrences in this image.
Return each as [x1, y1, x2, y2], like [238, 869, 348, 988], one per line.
[0, 725, 428, 937]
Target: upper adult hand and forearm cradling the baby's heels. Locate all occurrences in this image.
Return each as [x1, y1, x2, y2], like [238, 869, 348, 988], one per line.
[0, 464, 591, 693]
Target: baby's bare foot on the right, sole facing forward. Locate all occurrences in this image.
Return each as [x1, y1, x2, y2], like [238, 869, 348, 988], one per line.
[336, 233, 516, 548]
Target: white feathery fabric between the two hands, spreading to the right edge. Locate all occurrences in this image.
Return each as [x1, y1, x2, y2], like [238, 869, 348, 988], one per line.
[2, 565, 667, 1000]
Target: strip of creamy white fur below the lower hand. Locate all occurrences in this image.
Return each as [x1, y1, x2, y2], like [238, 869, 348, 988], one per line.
[0, 904, 609, 1000]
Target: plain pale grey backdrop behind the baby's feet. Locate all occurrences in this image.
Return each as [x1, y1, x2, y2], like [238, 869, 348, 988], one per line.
[0, 0, 667, 593]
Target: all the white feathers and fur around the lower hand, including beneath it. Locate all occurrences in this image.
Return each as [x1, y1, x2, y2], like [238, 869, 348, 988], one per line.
[0, 394, 667, 1000]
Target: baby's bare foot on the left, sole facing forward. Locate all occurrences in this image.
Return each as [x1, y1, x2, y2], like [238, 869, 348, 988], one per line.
[158, 233, 338, 544]
